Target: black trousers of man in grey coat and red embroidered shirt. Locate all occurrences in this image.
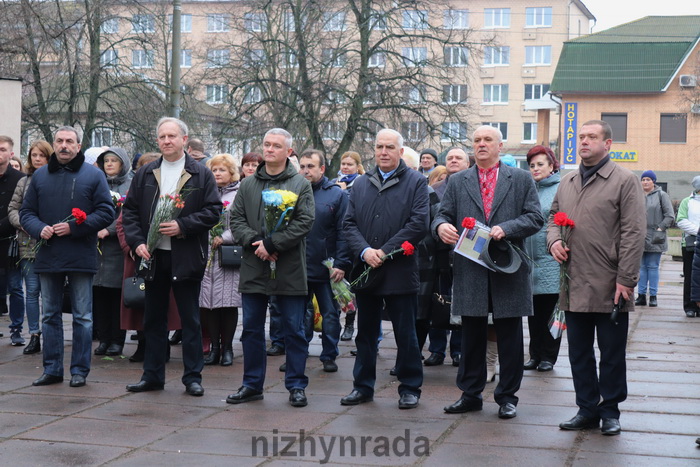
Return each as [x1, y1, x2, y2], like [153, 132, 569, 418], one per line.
[457, 316, 523, 405]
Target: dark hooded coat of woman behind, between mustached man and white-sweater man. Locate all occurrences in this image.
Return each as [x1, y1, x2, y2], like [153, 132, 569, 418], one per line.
[92, 148, 131, 289]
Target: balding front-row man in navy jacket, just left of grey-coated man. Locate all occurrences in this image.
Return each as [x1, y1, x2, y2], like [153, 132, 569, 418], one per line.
[340, 129, 429, 409]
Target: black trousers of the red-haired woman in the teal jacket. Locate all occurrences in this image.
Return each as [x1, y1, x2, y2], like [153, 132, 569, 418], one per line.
[527, 294, 561, 364]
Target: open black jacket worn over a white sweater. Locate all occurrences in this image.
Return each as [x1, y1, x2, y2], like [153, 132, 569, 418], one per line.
[122, 153, 223, 281]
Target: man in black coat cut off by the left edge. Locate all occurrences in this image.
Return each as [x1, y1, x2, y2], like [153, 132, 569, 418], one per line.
[0, 135, 25, 345]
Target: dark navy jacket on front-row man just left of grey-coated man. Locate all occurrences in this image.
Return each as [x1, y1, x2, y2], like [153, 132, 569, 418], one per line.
[343, 161, 429, 295]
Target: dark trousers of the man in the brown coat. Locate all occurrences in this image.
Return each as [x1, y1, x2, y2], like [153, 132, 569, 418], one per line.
[566, 311, 629, 418]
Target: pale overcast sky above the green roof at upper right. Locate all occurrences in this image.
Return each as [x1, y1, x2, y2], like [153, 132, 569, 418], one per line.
[582, 0, 700, 32]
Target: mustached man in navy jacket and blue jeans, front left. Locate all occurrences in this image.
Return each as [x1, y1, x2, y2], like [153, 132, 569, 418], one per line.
[19, 126, 114, 387]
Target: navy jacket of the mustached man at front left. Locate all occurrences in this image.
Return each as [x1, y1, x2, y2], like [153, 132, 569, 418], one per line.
[19, 152, 114, 274]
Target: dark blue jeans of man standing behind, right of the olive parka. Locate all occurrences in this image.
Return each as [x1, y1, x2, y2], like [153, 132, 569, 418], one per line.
[307, 282, 340, 362]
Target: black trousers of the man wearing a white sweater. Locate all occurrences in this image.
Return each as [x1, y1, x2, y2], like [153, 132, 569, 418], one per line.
[141, 250, 204, 385]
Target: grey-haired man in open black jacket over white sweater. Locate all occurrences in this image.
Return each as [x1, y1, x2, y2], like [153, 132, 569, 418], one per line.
[122, 117, 222, 396]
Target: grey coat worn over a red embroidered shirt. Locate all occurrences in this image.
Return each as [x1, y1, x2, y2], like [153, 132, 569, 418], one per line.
[431, 164, 544, 318]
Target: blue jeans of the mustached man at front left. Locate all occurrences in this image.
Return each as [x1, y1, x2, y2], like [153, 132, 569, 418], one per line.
[39, 272, 95, 376]
